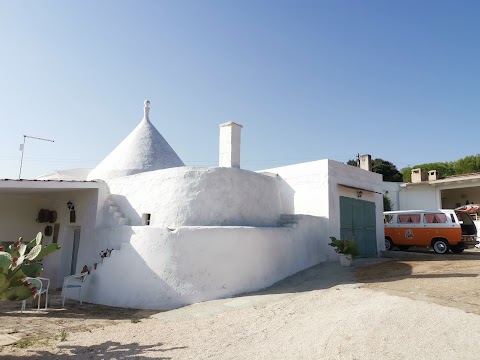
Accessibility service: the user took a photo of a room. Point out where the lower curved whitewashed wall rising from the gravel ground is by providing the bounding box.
[80,216,333,310]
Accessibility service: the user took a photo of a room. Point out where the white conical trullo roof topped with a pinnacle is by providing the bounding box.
[88,100,185,180]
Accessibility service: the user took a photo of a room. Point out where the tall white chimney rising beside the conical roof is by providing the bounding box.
[218,121,243,168]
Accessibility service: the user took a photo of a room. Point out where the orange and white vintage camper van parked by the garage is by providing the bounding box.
[383,210,478,254]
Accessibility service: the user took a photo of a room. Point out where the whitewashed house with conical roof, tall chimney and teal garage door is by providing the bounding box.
[0,102,384,309]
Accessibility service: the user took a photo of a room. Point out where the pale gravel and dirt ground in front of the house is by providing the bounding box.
[0,250,480,359]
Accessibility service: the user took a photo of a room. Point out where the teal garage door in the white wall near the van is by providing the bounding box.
[340,196,377,257]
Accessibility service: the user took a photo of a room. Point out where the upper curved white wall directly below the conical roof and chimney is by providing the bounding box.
[104,167,281,228]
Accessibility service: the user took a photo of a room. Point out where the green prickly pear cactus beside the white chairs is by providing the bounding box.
[0,233,60,301]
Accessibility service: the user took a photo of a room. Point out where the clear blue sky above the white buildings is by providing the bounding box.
[0,0,480,178]
